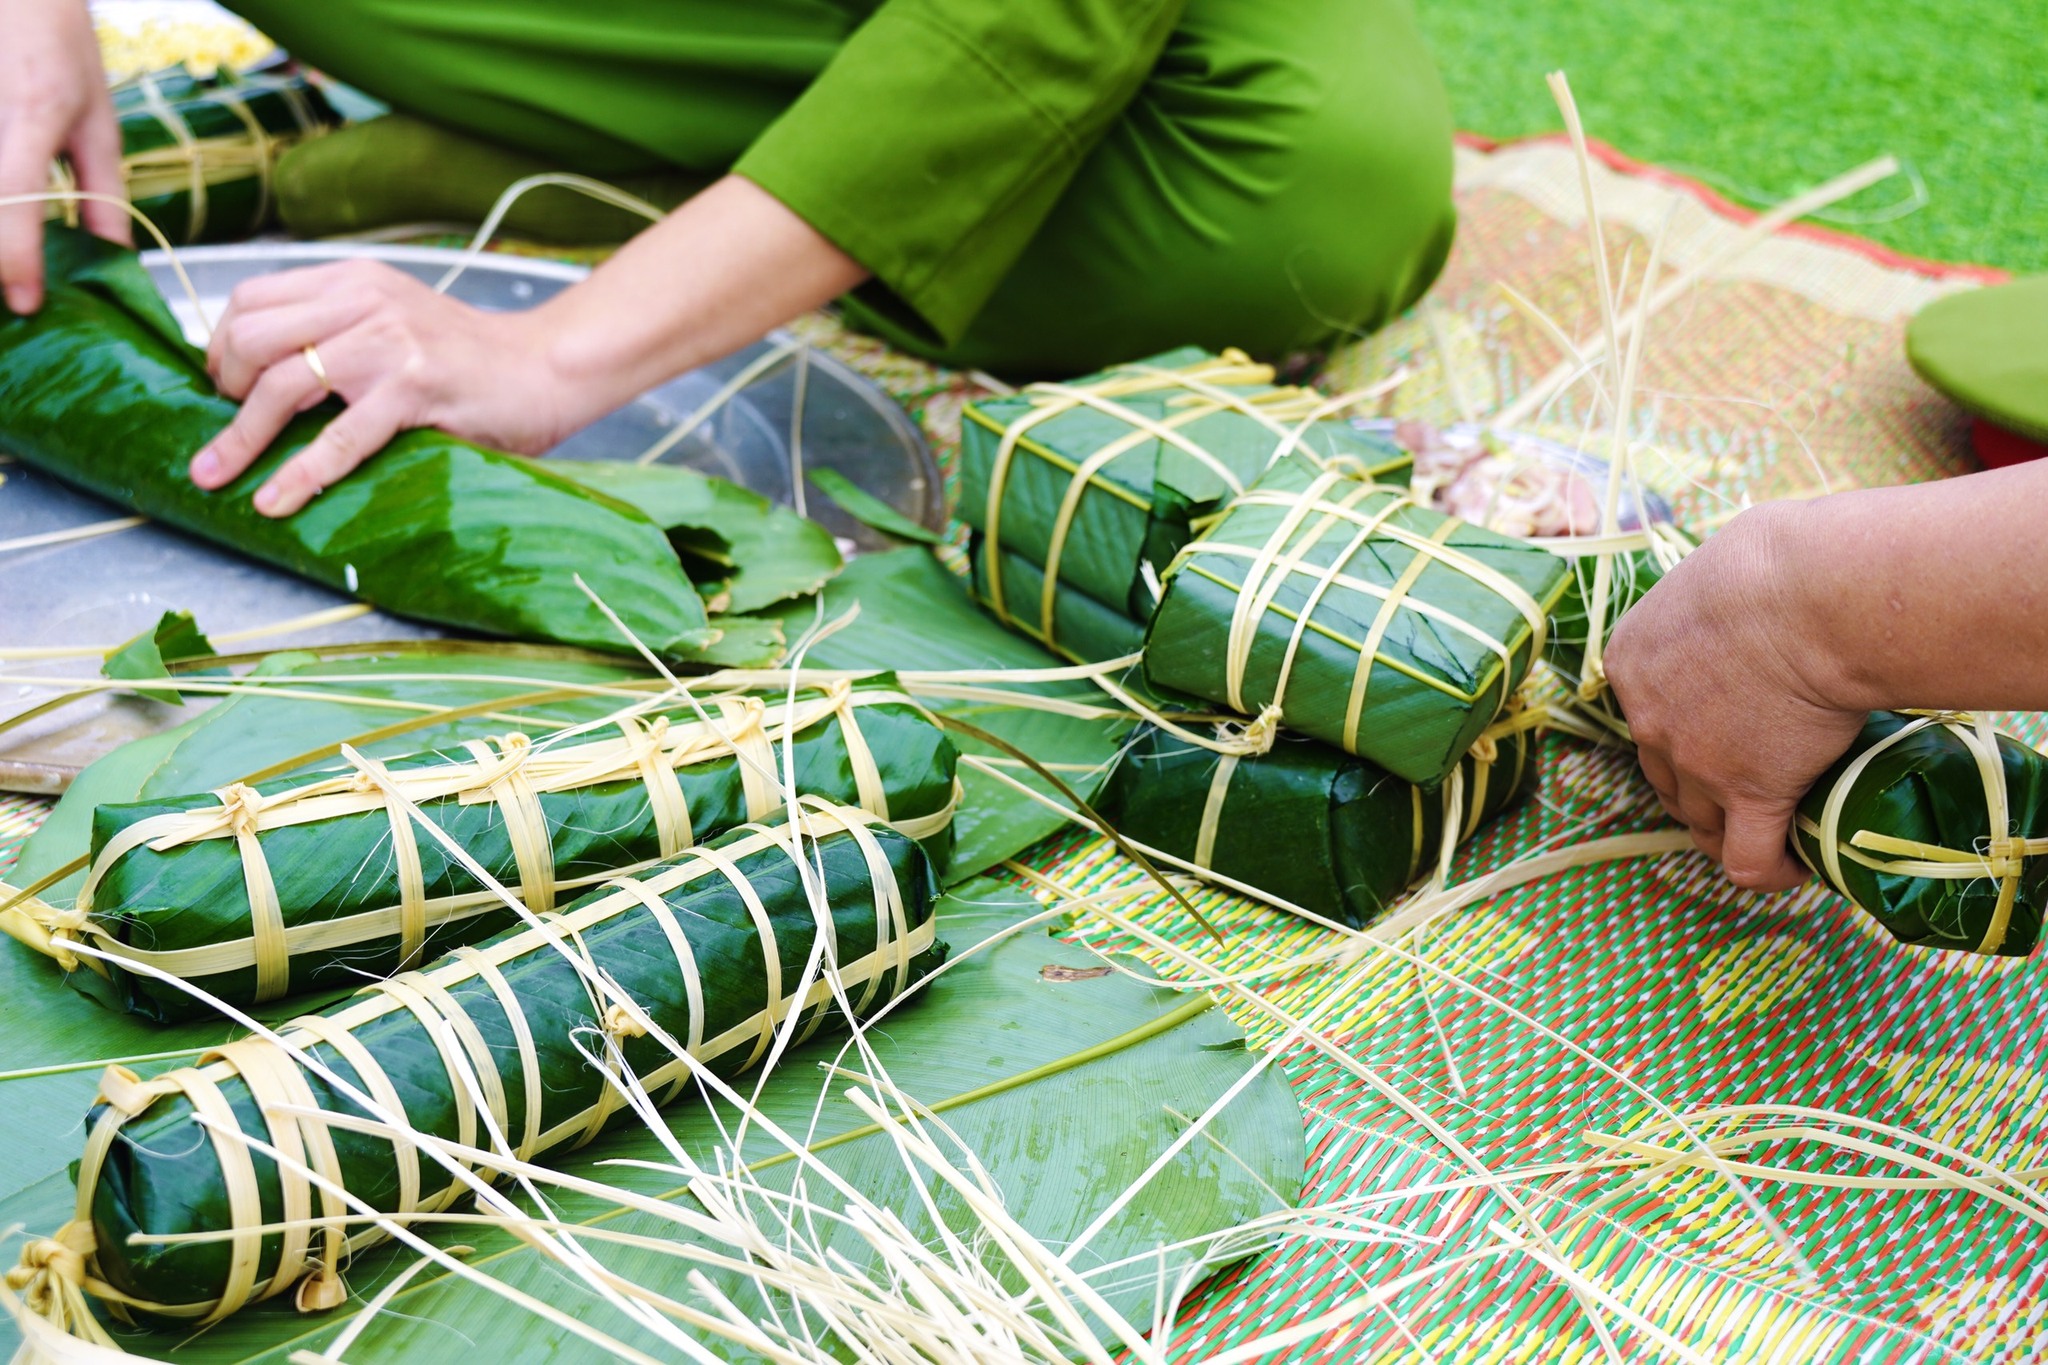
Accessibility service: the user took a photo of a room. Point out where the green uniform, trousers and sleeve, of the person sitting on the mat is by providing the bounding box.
[233,0,1454,377]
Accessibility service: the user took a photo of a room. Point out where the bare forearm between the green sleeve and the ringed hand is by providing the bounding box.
[530,176,866,428]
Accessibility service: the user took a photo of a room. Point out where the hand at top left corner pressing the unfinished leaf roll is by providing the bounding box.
[0,0,131,313]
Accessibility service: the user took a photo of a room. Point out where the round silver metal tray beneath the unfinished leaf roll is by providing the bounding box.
[0,241,944,792]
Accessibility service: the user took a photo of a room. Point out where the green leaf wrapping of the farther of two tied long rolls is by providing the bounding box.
[72,675,954,1019]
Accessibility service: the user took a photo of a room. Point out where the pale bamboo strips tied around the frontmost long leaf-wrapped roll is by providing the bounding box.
[8,798,938,1347]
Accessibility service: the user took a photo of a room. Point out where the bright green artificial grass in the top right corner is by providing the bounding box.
[1415,0,2048,274]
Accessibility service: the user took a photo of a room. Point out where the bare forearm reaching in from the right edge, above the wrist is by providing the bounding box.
[1751,463,2048,710]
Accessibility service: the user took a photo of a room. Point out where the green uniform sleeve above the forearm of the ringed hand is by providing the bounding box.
[733,0,1184,346]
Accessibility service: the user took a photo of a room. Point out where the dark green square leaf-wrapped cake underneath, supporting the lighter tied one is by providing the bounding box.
[1100,720,1536,929]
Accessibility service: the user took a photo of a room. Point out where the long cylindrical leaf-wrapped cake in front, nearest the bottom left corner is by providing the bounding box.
[25,802,946,1326]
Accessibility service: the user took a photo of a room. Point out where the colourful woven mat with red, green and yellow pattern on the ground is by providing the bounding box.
[0,141,2048,1361]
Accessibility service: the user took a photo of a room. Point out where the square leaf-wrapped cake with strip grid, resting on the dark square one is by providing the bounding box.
[1145,456,1571,786]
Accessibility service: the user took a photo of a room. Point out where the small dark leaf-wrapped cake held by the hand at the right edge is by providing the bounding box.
[1794,710,2048,958]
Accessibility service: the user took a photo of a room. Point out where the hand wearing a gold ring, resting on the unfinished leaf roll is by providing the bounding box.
[190,262,581,516]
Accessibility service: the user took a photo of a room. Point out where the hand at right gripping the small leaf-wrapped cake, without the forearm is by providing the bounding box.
[1606,503,1866,890]
